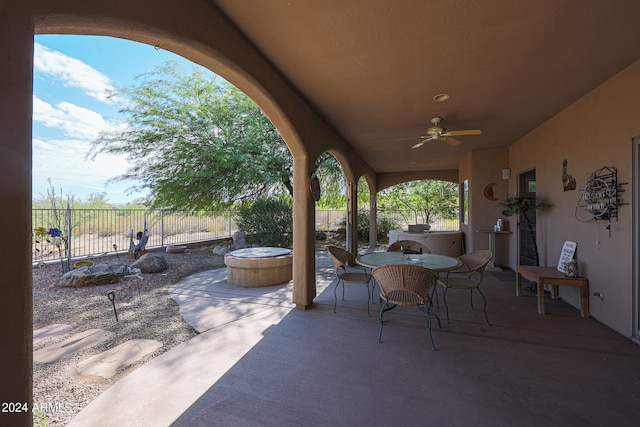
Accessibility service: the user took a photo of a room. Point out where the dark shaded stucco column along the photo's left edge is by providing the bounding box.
[0,6,33,426]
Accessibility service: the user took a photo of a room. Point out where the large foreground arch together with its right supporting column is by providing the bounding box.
[26,0,376,308]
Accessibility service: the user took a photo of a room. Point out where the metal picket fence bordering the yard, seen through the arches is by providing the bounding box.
[32,209,458,262]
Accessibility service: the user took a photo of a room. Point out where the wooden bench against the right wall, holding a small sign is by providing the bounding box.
[516,265,589,317]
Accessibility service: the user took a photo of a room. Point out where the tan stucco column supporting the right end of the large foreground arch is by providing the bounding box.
[293,156,316,309]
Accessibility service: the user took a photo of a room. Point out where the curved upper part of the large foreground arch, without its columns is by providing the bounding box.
[33,0,312,157]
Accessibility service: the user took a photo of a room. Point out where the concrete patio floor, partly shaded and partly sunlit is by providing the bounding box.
[70,252,640,427]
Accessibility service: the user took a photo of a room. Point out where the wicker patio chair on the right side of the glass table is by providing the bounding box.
[438,249,493,325]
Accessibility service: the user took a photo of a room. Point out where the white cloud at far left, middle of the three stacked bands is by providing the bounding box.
[33,95,120,139]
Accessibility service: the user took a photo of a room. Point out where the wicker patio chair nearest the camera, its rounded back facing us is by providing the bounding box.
[371,264,441,350]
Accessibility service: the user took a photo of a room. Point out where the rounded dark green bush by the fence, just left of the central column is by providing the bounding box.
[237,198,293,248]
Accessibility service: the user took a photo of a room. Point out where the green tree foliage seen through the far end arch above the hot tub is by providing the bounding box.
[378,181,458,224]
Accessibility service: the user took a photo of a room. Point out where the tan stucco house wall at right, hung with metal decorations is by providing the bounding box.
[509,61,640,336]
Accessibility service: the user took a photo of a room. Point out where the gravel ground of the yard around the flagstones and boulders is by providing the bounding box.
[33,233,344,426]
